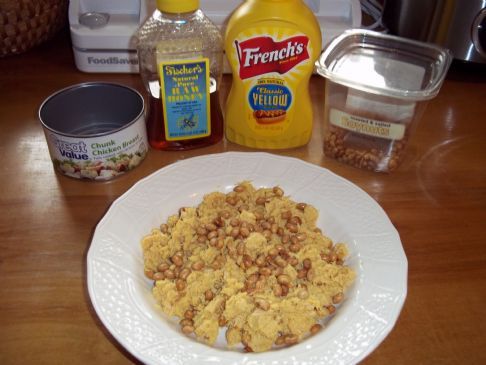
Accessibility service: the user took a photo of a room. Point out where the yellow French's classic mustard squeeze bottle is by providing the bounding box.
[225,0,322,149]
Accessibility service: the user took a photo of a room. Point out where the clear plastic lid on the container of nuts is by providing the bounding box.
[316,29,452,100]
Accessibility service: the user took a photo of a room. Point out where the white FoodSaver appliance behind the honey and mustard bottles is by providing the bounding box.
[69,0,361,72]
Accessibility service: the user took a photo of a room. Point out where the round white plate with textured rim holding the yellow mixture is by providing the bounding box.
[88,153,407,365]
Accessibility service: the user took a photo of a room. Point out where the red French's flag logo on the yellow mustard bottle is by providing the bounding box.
[235,35,309,80]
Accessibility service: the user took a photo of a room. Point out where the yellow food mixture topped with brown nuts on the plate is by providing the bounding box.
[142,182,355,352]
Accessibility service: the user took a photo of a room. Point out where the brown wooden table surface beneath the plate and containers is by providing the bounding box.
[0,32,486,365]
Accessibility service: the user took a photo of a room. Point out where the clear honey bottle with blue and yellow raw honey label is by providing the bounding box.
[136,0,223,150]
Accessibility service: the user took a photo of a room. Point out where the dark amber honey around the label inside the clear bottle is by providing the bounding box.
[147,91,224,151]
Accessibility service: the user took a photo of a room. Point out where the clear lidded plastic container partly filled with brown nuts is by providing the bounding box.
[316,29,452,172]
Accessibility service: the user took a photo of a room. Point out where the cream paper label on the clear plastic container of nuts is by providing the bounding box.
[329,109,405,140]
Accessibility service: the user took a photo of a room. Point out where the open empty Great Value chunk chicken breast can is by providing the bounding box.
[39,82,148,180]
